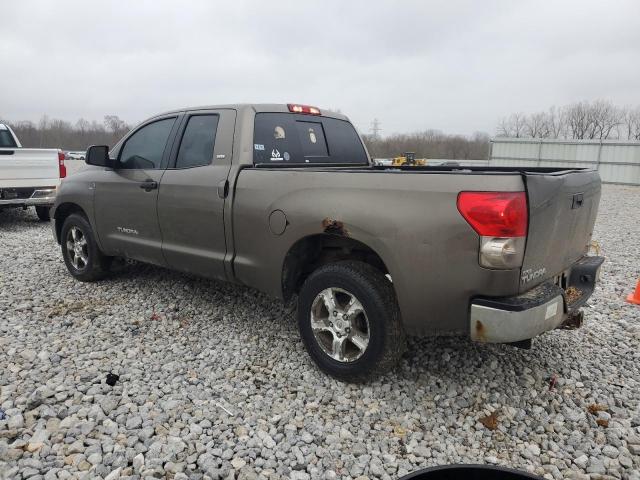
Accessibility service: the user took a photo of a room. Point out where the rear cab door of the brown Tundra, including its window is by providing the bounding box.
[158,109,236,280]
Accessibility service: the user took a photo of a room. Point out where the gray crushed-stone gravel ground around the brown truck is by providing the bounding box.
[0,186,640,480]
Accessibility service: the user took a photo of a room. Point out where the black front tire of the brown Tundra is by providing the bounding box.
[60,213,113,282]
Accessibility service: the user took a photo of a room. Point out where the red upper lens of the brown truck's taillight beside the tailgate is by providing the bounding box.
[458,192,528,237]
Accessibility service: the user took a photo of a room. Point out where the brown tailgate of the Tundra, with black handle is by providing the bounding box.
[520,170,601,292]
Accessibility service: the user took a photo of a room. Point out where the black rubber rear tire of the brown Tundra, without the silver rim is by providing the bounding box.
[297,261,406,382]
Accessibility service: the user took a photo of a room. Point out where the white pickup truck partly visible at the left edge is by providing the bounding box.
[0,123,67,221]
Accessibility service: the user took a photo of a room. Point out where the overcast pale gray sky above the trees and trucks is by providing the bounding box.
[0,0,640,134]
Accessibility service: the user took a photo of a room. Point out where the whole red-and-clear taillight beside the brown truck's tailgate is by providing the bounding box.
[458,192,529,268]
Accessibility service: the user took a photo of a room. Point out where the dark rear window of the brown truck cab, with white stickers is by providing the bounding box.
[253,113,368,165]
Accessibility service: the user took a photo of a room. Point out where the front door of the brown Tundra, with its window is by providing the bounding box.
[94,115,179,265]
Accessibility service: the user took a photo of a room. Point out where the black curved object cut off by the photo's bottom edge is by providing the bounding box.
[401,465,542,480]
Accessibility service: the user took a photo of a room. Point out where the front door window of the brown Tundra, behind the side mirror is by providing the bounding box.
[119,118,176,170]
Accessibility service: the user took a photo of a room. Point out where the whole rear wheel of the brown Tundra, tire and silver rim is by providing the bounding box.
[297,261,406,382]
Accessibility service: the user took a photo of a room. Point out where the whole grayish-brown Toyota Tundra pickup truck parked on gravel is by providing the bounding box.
[52,104,603,381]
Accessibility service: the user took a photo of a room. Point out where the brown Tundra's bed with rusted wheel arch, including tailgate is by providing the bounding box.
[233,165,600,334]
